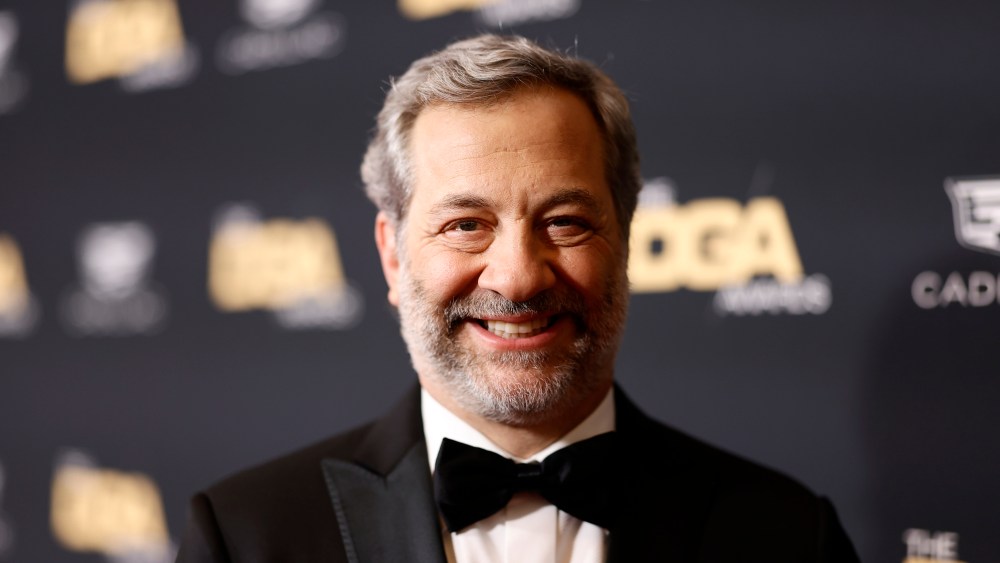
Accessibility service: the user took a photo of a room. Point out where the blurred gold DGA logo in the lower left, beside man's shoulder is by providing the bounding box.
[50,450,175,563]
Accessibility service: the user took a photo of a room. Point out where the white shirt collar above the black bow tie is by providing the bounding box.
[420,387,615,471]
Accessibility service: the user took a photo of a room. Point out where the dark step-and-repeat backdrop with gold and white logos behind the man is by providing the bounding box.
[0,0,1000,563]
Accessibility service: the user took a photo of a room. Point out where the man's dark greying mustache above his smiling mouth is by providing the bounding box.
[444,290,587,330]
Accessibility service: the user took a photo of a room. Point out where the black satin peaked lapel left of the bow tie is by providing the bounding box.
[323,388,445,563]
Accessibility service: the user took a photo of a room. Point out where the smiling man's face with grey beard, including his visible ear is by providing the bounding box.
[377,88,628,425]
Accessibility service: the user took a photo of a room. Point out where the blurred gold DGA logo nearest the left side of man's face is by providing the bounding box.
[208,205,363,329]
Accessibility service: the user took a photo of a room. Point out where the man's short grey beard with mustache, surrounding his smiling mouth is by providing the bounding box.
[399,266,628,426]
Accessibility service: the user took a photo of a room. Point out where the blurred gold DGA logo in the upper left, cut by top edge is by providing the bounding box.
[66,0,198,92]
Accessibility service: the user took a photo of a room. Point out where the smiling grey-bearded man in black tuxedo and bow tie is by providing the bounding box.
[178,35,857,563]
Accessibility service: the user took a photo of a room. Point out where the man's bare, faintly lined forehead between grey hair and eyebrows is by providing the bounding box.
[402,87,610,210]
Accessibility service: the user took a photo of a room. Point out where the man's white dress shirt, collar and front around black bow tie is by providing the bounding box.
[420,389,615,563]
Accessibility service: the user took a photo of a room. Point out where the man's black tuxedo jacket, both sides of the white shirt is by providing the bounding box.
[177,389,858,563]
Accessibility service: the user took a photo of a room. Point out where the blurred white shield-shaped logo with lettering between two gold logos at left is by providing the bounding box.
[62,221,167,336]
